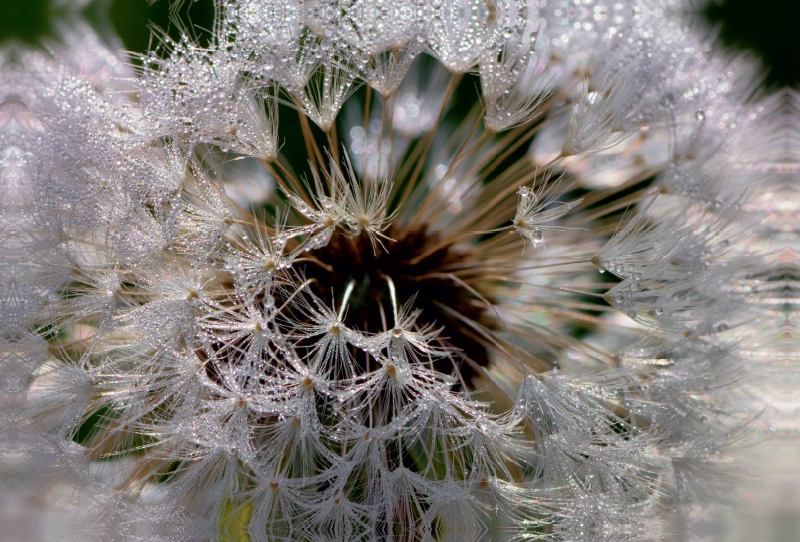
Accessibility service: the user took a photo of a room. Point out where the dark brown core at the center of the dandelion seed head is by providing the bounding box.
[303,228,493,383]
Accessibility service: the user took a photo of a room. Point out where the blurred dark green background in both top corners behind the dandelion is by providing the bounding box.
[0,0,800,87]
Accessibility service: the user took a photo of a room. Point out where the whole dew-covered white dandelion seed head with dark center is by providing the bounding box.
[0,0,780,542]
